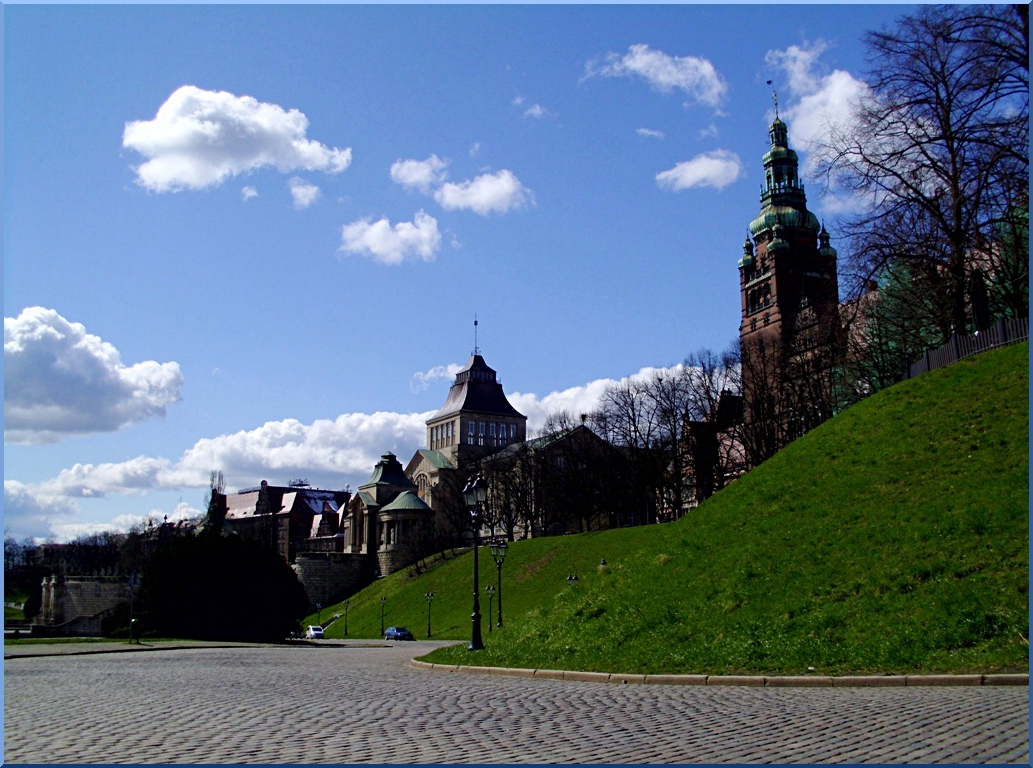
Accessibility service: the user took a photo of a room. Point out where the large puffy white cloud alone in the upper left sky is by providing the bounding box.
[122,86,351,192]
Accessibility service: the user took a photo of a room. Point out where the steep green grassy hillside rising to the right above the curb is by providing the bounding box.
[311,344,1029,674]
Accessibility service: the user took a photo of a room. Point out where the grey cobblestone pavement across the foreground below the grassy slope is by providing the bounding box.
[4,643,1029,764]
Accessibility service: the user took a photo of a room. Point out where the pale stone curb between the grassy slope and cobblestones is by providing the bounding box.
[409,658,1030,688]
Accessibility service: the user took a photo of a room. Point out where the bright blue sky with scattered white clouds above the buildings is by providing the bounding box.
[4,5,908,540]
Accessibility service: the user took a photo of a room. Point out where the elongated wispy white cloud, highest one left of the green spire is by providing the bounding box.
[585,43,728,107]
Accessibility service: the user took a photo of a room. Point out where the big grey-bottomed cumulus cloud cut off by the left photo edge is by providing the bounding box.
[3,307,183,443]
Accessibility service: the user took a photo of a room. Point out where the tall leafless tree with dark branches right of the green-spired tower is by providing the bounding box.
[819,5,1029,341]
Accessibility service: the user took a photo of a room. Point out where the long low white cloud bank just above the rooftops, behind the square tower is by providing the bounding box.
[4,364,706,541]
